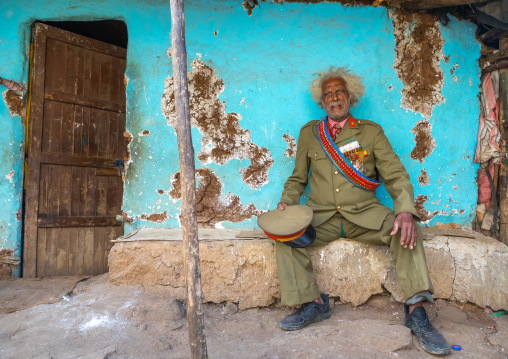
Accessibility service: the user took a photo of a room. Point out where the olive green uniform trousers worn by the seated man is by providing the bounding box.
[276,212,434,306]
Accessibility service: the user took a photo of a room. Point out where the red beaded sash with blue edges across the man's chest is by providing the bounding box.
[316,117,381,191]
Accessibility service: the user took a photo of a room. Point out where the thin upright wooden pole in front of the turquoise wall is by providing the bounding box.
[171,0,208,359]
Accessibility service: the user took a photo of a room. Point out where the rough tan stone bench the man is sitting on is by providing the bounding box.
[109,228,508,310]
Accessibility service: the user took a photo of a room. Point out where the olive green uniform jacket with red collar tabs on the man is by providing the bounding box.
[280,120,419,230]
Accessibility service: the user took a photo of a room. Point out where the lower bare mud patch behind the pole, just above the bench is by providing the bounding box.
[169,168,261,227]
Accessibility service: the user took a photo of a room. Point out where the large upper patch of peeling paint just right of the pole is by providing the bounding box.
[161,59,273,189]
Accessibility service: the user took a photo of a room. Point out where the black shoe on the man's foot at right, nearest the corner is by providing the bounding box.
[404,304,450,354]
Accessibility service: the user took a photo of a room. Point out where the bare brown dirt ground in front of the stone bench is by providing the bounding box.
[0,274,508,359]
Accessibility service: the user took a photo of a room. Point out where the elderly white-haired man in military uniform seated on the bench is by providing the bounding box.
[276,68,449,354]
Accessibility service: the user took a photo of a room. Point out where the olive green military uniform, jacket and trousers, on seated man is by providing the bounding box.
[276,119,433,305]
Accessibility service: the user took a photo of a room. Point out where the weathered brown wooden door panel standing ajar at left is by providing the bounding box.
[23,24,126,277]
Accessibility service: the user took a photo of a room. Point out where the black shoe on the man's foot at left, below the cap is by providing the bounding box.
[279,294,330,330]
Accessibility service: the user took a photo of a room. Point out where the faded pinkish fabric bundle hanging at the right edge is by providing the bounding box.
[474,71,501,208]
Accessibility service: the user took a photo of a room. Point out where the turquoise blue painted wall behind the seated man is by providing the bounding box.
[0,0,480,276]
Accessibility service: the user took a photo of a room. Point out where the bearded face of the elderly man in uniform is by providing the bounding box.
[321,77,351,121]
